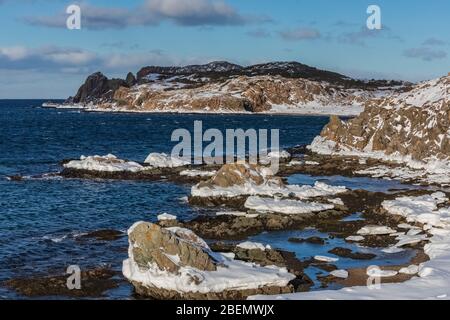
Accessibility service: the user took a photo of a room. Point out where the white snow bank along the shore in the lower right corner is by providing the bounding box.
[250,194,450,300]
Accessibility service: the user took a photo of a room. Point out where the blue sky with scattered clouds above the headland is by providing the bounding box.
[0,0,450,99]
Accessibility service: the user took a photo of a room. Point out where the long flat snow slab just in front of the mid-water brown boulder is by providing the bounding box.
[244,196,334,214]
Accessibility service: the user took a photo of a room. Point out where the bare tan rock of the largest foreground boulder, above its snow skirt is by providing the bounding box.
[129,223,216,273]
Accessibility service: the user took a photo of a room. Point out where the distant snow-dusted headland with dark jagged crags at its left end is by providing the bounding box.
[59,62,404,114]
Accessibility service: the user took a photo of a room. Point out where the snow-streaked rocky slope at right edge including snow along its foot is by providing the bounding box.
[309,76,450,185]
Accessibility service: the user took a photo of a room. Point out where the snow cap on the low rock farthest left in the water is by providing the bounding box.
[64,154,144,173]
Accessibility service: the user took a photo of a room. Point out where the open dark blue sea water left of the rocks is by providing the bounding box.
[0,100,328,298]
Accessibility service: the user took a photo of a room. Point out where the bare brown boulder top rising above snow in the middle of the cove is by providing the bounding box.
[198,163,283,188]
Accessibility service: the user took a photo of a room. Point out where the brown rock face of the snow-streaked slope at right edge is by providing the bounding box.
[321,76,450,160]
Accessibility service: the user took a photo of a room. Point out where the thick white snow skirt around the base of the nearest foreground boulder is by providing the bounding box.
[122,224,295,293]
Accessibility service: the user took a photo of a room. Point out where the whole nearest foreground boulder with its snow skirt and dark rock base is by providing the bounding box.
[122,222,295,300]
